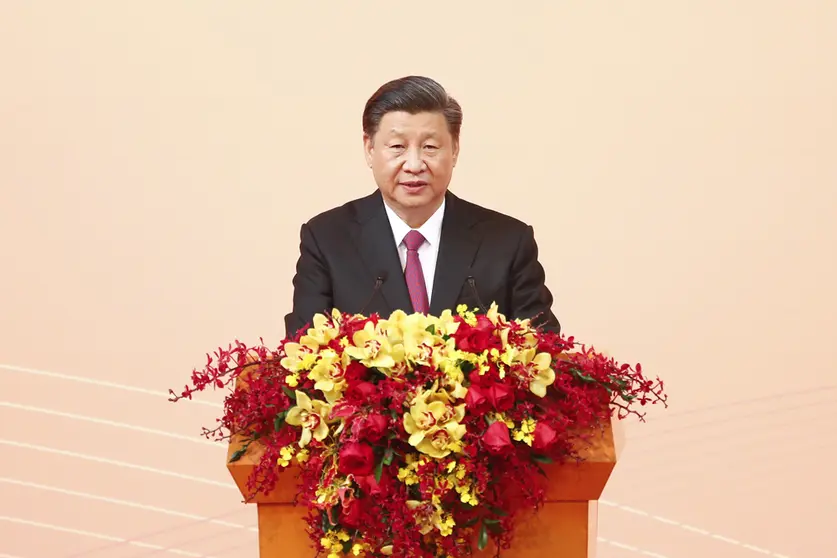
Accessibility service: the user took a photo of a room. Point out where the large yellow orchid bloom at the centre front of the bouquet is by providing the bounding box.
[404,386,466,459]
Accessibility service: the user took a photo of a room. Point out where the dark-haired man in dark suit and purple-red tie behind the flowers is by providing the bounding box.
[285,76,560,337]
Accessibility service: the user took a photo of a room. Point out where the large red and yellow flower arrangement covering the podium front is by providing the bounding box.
[170,304,666,558]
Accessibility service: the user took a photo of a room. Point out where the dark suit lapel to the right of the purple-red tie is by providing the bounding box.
[430,192,480,316]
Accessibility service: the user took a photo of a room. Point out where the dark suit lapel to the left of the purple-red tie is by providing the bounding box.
[353,191,412,315]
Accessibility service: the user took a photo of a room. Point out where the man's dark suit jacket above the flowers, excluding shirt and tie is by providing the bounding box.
[285,190,561,337]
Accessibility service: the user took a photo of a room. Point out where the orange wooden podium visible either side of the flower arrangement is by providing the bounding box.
[227,419,623,558]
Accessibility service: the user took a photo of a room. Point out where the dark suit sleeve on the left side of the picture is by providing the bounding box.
[285,224,334,338]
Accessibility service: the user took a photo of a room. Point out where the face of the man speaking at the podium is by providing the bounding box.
[363,112,459,227]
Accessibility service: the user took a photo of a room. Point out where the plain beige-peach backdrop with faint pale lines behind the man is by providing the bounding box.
[0,0,837,558]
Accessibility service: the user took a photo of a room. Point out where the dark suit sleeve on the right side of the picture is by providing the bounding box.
[511,225,561,333]
